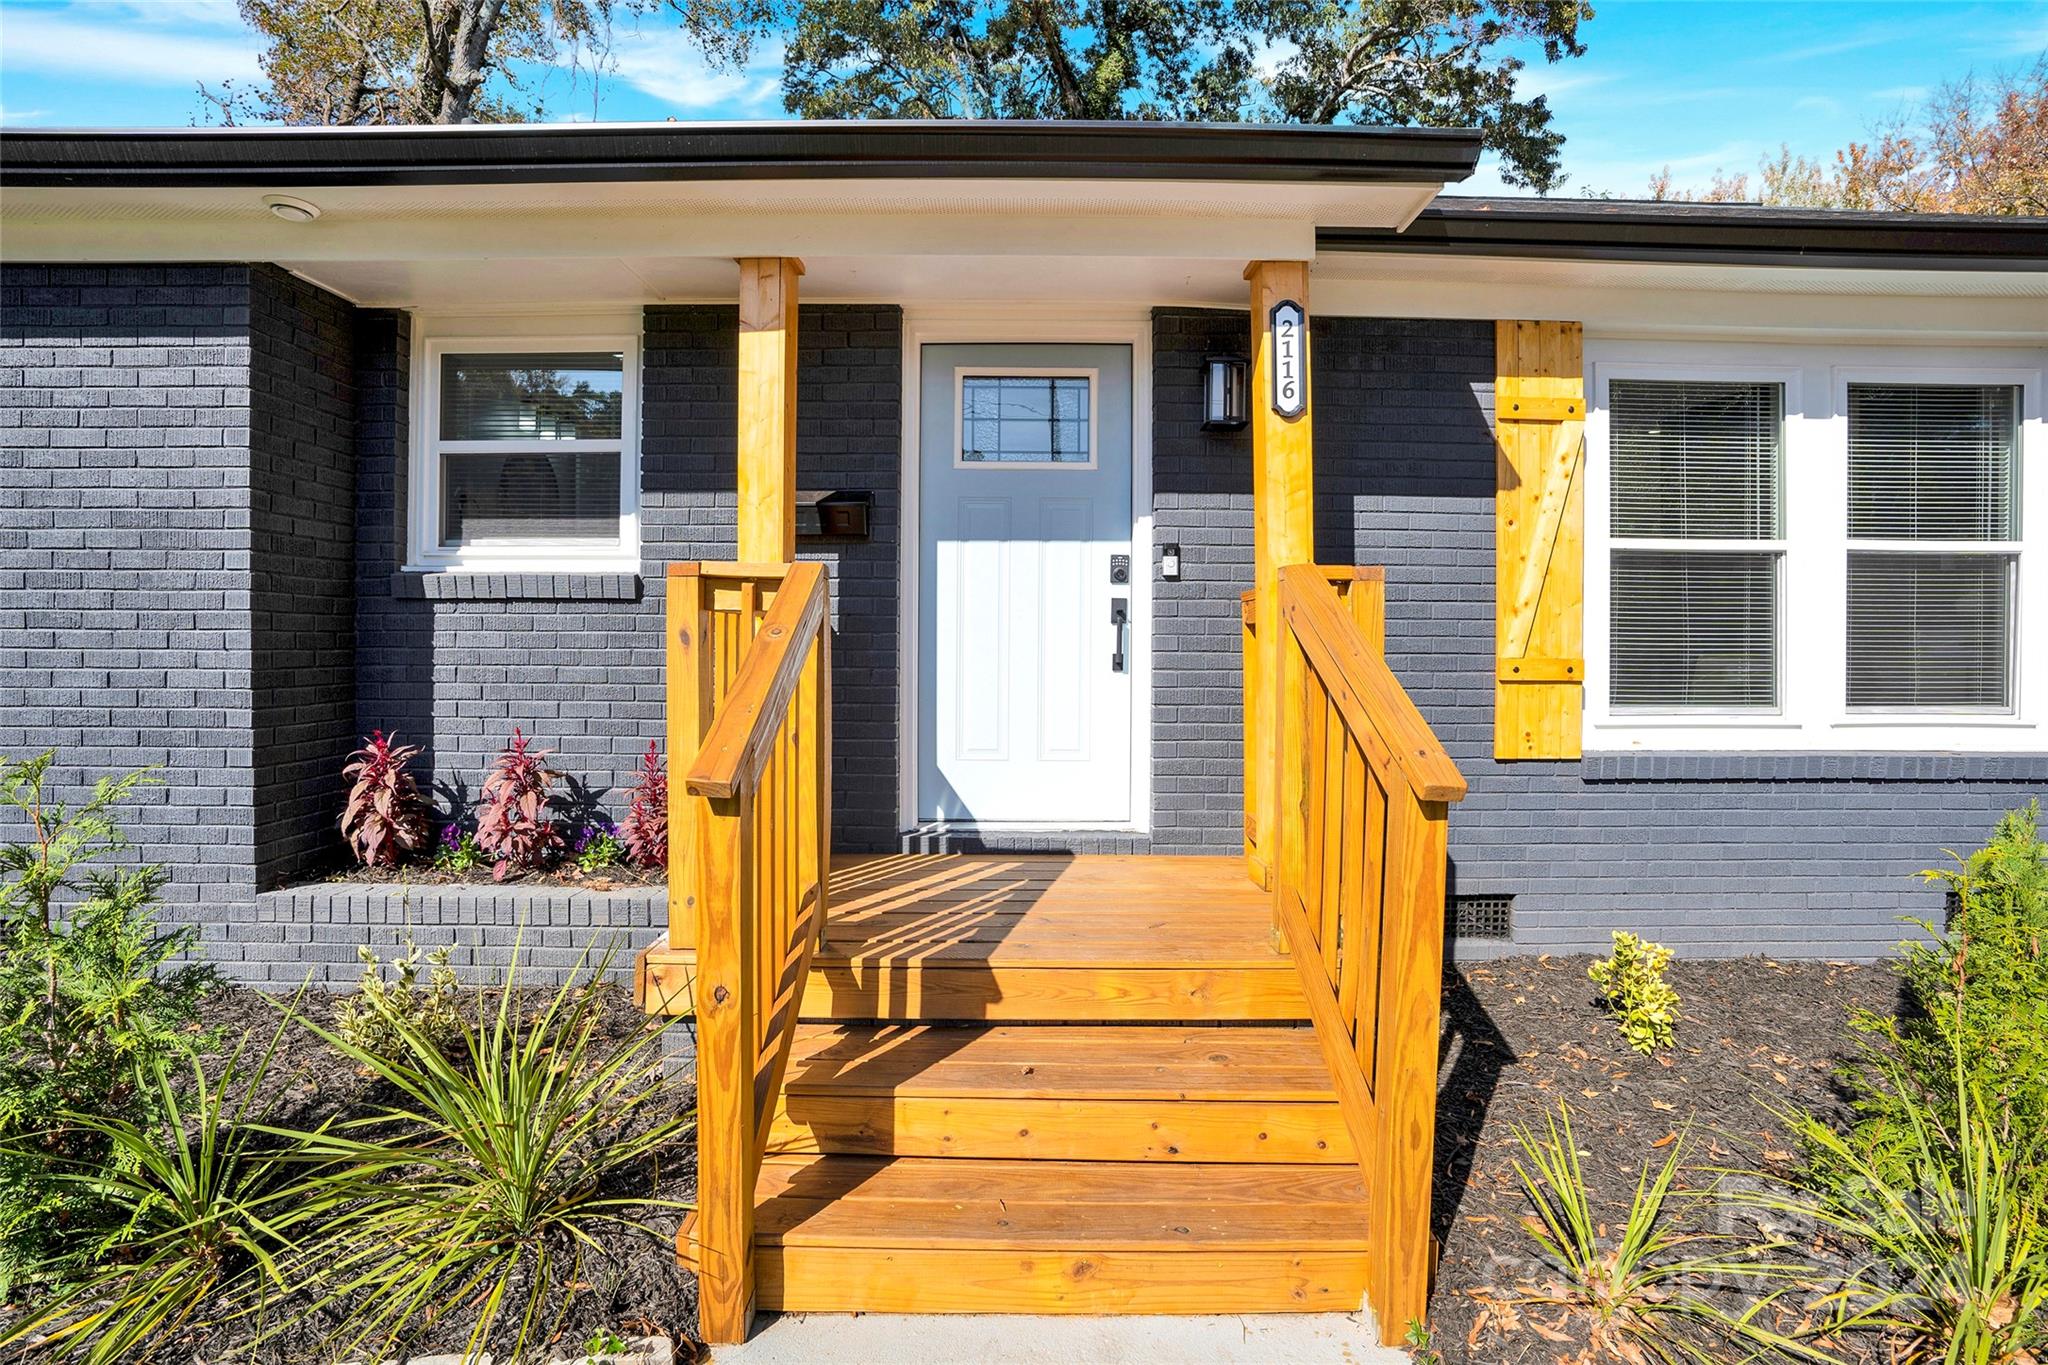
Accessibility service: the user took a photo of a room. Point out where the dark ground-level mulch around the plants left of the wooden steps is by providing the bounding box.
[153,986,696,1365]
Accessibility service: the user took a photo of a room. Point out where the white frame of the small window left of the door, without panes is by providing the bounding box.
[406,315,641,573]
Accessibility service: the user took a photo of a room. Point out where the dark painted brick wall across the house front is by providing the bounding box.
[0,266,2044,980]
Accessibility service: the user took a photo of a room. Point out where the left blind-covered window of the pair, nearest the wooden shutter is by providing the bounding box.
[1608,379,1784,710]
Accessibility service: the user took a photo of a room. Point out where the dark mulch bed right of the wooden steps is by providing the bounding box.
[1432,958,1898,1365]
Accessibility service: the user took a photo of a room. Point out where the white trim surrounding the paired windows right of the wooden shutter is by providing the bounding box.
[1583,338,2048,753]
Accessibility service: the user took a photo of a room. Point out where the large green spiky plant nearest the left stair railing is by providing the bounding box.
[256,945,694,1359]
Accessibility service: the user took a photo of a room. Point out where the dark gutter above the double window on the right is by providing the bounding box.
[1315,199,2048,270]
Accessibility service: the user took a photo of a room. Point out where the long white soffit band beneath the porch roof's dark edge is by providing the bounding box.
[0,180,1440,262]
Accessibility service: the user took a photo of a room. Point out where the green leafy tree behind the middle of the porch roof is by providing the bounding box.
[684,0,1593,190]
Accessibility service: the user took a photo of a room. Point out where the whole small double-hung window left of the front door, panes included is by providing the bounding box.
[412,338,639,571]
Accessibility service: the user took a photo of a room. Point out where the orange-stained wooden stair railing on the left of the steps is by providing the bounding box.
[668,563,831,1342]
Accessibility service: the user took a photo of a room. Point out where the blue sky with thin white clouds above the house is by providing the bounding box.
[0,0,2048,194]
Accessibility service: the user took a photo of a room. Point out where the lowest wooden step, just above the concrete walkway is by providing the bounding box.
[754,1156,1366,1314]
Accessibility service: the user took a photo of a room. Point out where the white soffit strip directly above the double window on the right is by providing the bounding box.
[1313,252,2048,342]
